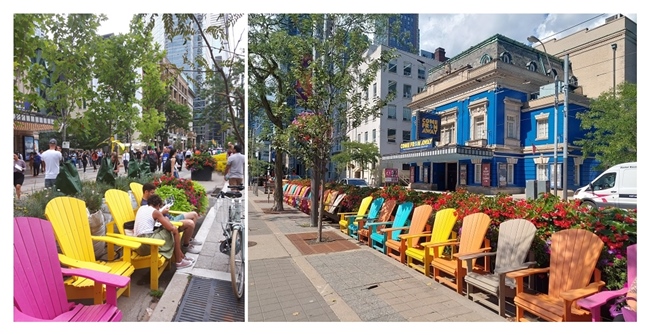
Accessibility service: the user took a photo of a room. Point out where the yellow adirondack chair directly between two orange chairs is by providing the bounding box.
[403,208,458,276]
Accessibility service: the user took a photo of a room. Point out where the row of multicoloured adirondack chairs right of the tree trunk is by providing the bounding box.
[339,196,636,321]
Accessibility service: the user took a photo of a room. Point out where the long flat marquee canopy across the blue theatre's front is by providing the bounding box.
[381,145,494,164]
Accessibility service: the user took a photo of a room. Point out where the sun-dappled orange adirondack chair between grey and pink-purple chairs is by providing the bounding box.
[506,229,605,322]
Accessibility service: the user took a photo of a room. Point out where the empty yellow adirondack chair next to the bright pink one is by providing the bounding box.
[44,197,140,304]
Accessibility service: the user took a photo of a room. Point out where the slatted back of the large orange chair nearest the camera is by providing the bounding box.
[548,229,604,298]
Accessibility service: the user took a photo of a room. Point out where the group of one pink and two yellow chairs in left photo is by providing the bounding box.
[14,184,186,321]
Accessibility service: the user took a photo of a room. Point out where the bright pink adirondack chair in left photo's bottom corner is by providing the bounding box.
[14,217,131,322]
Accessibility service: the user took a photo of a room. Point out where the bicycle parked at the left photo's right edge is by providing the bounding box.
[213,185,246,299]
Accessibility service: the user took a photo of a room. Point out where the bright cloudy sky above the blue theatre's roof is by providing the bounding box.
[420,13,636,58]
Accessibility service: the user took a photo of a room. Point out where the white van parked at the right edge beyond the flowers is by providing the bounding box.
[573,162,637,209]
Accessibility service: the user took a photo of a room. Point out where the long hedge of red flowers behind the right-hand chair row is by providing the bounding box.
[326,184,637,289]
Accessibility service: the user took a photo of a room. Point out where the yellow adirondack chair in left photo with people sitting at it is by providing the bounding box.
[104,189,183,290]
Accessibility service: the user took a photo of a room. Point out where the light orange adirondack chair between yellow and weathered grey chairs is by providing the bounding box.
[427,213,491,294]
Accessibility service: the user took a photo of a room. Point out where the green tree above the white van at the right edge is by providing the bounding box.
[575,82,637,169]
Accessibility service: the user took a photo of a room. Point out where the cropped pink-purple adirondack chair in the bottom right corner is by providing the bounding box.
[578,244,636,322]
